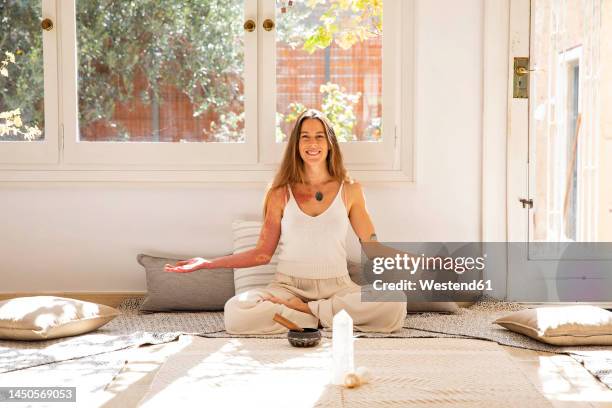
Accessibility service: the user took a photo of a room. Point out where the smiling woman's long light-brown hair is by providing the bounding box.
[263,109,352,220]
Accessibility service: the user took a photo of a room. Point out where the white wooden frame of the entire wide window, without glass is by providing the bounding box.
[0,0,415,183]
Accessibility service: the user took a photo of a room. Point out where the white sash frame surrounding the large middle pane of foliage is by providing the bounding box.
[60,0,257,168]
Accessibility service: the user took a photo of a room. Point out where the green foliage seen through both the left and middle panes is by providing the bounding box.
[0,0,244,138]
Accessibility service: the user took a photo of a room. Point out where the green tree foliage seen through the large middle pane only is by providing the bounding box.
[77,0,244,140]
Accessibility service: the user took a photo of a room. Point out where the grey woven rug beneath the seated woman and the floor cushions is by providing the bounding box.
[0,297,612,389]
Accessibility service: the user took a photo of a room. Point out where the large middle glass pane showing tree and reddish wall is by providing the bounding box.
[76,0,244,142]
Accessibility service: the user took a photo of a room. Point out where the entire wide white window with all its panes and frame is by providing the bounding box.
[0,0,412,178]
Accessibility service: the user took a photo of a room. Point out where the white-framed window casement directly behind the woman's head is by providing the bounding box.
[262,0,405,166]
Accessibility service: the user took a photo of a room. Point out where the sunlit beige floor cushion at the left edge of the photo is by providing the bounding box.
[0,296,120,340]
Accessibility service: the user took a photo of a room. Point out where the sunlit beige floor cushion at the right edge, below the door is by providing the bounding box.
[495,305,612,346]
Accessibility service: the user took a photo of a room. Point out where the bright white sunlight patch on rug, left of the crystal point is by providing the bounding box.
[142,339,331,407]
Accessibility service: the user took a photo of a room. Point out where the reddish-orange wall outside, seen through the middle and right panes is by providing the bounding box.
[81,38,382,142]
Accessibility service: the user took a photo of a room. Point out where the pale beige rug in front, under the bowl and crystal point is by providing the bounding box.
[138,338,552,408]
